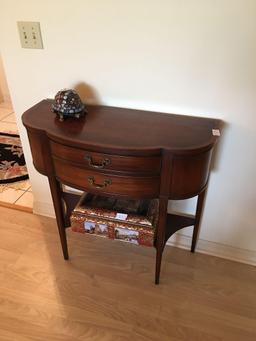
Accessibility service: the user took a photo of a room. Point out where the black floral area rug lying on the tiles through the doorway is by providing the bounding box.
[0,133,28,184]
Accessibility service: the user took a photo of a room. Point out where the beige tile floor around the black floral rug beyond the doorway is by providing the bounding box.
[0,103,33,212]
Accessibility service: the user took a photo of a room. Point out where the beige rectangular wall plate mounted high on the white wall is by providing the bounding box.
[17,21,43,49]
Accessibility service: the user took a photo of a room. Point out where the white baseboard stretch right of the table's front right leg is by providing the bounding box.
[167,233,256,265]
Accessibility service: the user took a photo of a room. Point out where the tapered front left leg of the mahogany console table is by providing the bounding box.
[48,178,68,259]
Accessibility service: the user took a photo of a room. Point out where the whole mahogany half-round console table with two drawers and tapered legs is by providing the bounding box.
[22,100,220,284]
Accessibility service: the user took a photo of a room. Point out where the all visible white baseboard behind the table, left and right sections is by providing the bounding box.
[33,201,256,265]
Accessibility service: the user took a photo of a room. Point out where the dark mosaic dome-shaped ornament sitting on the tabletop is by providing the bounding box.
[52,89,85,120]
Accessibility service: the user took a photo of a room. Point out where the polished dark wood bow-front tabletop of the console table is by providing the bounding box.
[22,100,220,156]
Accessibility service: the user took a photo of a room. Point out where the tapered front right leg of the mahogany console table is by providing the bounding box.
[155,198,168,284]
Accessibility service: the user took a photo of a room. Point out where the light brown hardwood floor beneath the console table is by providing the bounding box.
[0,207,256,341]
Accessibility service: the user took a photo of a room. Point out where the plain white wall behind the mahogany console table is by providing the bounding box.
[0,0,256,260]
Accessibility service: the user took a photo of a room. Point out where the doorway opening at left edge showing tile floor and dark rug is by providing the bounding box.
[0,55,33,212]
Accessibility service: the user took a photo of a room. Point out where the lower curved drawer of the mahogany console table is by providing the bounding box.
[53,158,160,198]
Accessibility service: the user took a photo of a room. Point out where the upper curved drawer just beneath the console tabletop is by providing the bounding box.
[50,141,161,174]
